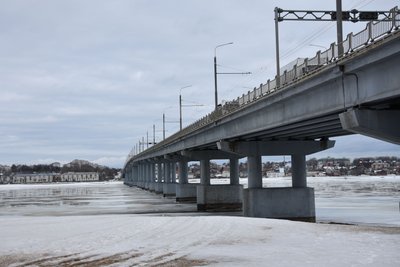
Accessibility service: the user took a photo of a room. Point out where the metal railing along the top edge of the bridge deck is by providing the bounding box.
[127,7,400,165]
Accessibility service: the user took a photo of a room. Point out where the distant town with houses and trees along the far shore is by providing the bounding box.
[0,156,400,184]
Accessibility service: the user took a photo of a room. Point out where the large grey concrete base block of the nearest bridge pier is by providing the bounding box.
[243,187,315,222]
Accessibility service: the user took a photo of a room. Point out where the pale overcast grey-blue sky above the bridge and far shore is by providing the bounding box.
[0,0,400,167]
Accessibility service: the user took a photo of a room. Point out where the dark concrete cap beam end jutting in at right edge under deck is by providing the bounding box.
[339,109,400,145]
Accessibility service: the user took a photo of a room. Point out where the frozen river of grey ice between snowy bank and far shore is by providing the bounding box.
[0,176,400,226]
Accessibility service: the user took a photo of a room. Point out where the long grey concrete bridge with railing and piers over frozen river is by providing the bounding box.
[123,13,400,221]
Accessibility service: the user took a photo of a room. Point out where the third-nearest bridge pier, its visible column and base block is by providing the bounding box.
[176,160,197,203]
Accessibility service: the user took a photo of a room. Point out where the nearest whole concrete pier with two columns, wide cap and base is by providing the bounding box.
[219,140,335,221]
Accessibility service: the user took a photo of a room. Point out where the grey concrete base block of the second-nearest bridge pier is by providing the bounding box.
[197,185,243,211]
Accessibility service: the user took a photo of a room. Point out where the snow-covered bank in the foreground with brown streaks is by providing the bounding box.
[0,215,400,266]
